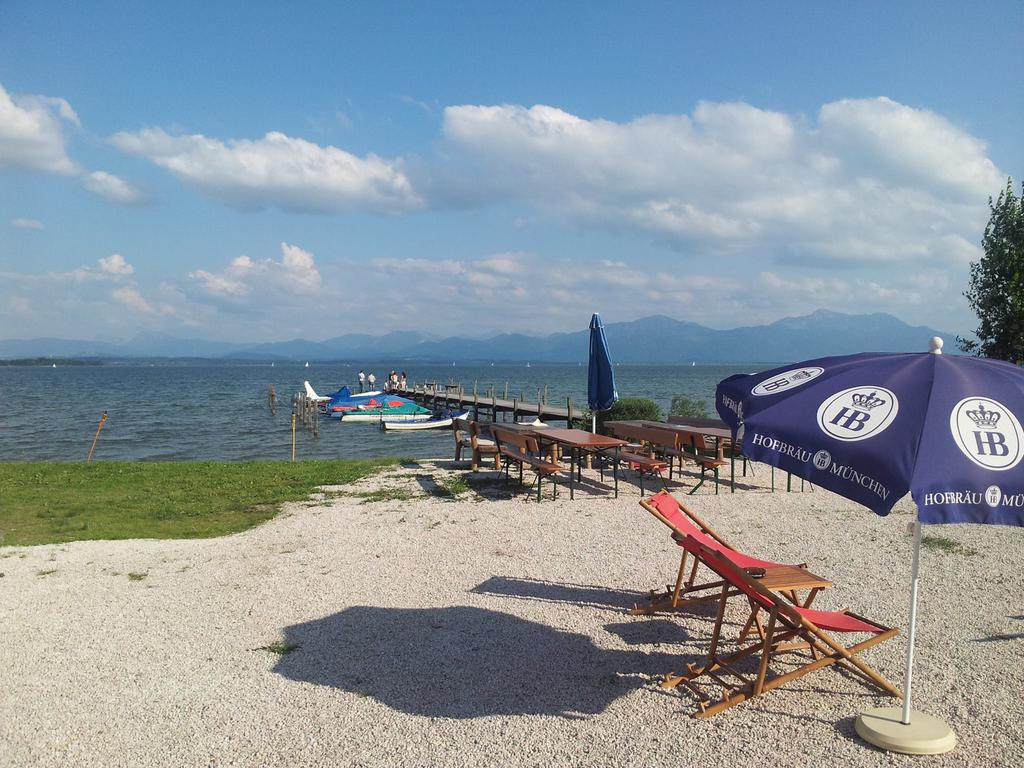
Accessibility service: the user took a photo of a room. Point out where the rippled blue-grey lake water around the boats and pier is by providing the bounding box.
[0,362,771,461]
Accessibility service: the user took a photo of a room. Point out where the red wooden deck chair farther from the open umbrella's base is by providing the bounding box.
[631,490,831,618]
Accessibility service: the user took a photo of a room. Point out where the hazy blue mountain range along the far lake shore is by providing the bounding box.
[0,309,955,364]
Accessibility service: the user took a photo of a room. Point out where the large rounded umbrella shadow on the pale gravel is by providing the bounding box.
[273,606,681,719]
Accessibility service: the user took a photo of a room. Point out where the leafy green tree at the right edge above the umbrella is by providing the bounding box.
[956,179,1024,362]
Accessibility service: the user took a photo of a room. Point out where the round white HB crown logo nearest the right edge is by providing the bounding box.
[949,397,1022,471]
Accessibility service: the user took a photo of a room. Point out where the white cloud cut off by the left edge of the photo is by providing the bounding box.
[0,85,79,175]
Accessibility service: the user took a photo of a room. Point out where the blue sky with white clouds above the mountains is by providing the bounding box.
[0,0,1024,341]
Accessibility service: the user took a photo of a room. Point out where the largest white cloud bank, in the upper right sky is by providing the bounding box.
[434,98,1005,264]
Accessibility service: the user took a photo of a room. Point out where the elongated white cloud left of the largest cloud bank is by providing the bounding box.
[111,128,422,213]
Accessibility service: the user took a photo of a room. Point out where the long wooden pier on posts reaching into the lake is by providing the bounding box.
[390,382,584,426]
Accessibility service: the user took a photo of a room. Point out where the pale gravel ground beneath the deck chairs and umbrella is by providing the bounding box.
[0,461,1024,766]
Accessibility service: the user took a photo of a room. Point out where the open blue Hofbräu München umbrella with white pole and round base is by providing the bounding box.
[715,338,1024,753]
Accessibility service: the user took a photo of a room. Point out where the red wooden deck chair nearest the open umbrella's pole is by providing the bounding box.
[662,537,902,718]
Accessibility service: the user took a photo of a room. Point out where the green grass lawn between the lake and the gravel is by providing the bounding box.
[0,459,395,546]
